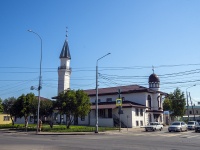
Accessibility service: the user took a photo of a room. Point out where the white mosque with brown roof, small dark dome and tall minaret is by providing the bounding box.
[58,33,167,128]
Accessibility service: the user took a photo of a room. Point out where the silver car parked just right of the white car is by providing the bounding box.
[168,121,188,132]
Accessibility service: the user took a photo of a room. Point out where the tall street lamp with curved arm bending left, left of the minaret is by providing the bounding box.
[28,30,42,134]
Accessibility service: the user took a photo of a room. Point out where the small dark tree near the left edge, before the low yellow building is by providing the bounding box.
[3,97,16,125]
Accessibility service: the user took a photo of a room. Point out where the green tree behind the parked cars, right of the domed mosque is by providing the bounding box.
[168,88,186,117]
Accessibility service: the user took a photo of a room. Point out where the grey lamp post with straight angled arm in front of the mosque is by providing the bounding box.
[95,53,110,133]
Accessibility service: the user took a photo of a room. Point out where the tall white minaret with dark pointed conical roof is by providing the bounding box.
[58,29,71,94]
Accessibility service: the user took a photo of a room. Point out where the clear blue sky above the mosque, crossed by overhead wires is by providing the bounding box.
[0,0,200,103]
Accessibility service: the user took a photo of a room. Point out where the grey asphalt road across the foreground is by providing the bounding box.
[0,129,200,150]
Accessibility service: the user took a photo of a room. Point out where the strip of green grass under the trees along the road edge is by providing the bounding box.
[0,124,118,132]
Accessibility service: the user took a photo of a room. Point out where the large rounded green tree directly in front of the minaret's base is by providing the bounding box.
[56,90,91,128]
